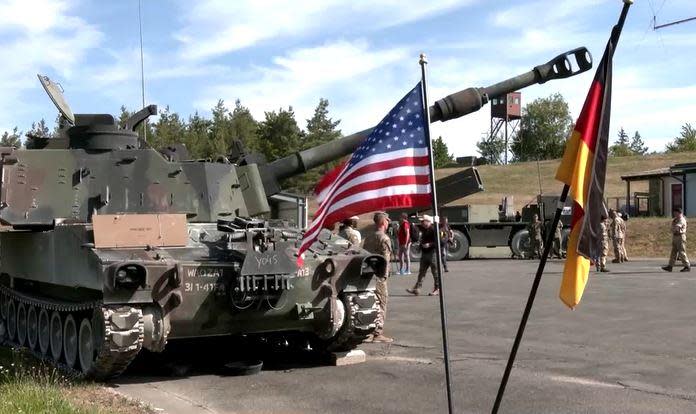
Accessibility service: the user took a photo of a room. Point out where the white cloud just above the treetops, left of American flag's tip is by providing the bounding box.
[196,40,407,132]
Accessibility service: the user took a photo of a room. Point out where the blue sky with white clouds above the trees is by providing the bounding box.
[0,0,696,156]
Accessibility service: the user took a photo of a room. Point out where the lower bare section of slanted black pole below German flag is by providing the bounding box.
[492,185,570,414]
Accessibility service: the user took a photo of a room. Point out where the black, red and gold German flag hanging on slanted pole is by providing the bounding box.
[556,19,623,309]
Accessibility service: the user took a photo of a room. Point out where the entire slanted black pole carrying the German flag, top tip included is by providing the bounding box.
[491,0,633,414]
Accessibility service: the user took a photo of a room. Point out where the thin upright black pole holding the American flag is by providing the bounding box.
[418,53,454,414]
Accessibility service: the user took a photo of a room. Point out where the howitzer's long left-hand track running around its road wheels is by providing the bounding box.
[0,285,144,381]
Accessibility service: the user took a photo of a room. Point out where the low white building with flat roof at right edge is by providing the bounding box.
[624,163,696,217]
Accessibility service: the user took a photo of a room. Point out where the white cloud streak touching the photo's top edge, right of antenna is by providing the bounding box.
[175,0,474,59]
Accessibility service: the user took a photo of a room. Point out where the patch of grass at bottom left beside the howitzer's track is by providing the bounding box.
[0,346,152,414]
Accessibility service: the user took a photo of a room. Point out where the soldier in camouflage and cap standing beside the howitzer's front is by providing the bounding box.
[363,212,394,342]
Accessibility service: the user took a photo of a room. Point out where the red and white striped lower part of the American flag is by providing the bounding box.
[298,147,430,263]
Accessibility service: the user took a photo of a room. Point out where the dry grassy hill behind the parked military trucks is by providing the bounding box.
[436,152,696,209]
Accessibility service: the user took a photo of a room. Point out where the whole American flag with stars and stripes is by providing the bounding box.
[298,82,431,265]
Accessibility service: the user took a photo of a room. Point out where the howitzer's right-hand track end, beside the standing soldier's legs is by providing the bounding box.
[326,291,379,352]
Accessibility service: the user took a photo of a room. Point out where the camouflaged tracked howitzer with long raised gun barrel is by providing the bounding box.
[0,49,591,379]
